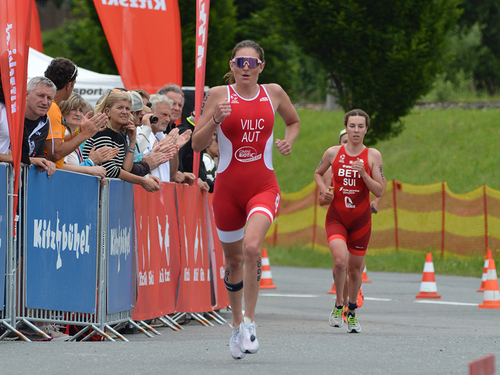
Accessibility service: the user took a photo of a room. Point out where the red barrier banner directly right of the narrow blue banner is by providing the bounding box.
[132,183,180,320]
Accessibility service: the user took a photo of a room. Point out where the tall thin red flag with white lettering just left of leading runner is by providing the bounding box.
[193,0,210,178]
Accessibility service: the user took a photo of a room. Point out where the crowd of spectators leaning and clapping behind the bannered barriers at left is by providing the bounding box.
[0,57,218,339]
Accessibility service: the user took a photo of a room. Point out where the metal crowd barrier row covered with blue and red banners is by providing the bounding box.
[0,164,229,341]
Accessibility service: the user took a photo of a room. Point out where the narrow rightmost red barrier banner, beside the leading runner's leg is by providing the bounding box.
[207,194,229,310]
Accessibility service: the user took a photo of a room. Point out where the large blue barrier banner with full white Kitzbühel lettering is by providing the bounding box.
[26,167,99,313]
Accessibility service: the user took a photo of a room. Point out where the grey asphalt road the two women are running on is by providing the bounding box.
[0,266,500,375]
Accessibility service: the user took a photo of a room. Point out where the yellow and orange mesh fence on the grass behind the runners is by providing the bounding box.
[265,180,500,256]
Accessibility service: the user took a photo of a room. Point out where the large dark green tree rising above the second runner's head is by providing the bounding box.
[271,0,460,144]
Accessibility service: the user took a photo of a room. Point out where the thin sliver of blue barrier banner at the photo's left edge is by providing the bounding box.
[0,164,7,311]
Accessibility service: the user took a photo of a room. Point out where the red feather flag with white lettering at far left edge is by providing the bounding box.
[0,0,32,216]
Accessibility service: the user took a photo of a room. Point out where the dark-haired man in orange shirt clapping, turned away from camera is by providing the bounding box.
[44,57,107,169]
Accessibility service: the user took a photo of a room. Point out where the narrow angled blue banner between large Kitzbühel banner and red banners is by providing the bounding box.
[107,180,134,314]
